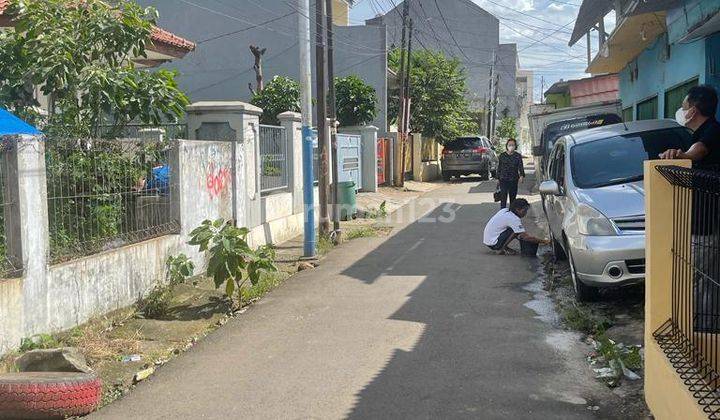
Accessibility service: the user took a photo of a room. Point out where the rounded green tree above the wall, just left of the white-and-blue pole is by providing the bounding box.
[250,76,300,125]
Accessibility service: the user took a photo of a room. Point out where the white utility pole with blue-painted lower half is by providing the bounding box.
[298,0,316,258]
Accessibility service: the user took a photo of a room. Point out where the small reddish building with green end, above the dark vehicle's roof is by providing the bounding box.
[543,74,619,108]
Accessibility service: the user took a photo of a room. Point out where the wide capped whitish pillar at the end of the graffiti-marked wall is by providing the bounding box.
[187,101,262,228]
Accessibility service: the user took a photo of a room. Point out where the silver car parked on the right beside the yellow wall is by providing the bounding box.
[540,120,691,301]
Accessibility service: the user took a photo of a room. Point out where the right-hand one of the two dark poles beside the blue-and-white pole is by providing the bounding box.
[325,0,341,243]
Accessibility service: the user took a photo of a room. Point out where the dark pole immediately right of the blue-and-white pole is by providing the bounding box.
[315,0,330,235]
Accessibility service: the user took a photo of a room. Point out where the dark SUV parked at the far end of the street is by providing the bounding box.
[440,137,498,181]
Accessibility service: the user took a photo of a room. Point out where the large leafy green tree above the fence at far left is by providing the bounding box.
[0,0,188,137]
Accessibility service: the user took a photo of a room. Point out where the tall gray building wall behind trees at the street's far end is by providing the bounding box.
[367,0,517,116]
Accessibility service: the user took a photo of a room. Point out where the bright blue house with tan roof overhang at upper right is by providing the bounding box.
[570,0,720,120]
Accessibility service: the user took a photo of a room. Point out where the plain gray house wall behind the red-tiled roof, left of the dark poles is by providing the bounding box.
[138,0,387,132]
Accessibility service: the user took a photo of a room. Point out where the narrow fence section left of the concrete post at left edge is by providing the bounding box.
[0,137,22,278]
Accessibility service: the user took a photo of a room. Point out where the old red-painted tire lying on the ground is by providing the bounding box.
[0,372,102,419]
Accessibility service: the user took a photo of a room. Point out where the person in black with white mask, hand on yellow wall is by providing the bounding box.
[660,85,720,170]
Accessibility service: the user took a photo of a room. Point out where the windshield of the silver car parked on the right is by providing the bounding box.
[570,127,692,188]
